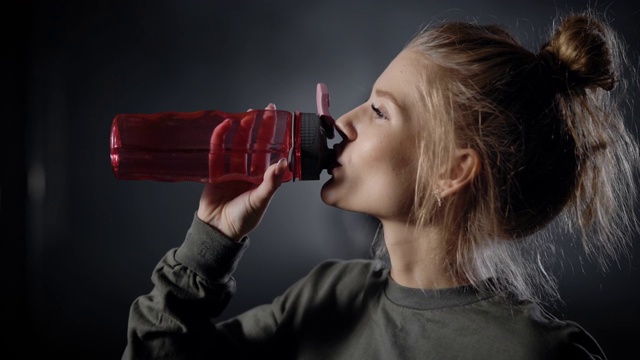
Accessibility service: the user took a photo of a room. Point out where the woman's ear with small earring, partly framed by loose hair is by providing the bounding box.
[436,149,481,198]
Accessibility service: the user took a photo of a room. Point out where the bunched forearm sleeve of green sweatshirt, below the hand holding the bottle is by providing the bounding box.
[122,215,249,359]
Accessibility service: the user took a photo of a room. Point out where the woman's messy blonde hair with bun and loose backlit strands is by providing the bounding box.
[378,13,639,300]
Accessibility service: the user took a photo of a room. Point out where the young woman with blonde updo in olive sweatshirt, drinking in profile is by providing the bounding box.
[124,14,639,359]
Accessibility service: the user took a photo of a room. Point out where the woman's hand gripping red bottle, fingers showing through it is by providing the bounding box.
[197,104,288,241]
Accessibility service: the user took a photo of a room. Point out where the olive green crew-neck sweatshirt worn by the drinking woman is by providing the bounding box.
[123,217,605,360]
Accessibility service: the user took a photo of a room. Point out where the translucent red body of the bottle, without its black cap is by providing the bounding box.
[110,110,293,184]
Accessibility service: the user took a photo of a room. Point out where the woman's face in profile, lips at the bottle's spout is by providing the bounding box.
[321,50,424,221]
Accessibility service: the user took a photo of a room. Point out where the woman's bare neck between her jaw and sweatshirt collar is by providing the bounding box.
[382,221,461,289]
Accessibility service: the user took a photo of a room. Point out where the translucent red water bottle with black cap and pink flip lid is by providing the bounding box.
[110,83,335,184]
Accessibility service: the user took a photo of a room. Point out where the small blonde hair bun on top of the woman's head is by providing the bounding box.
[538,15,616,91]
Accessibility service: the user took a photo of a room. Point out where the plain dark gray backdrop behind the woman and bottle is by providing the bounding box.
[0,0,640,359]
